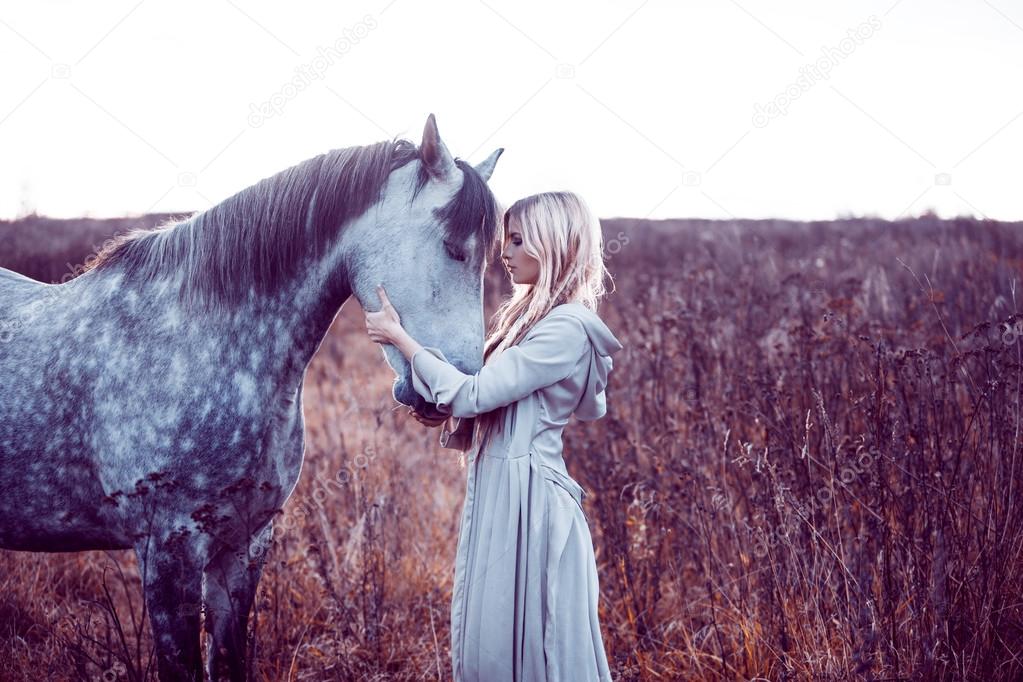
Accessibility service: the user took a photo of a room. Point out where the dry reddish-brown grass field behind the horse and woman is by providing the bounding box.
[0,211,1023,682]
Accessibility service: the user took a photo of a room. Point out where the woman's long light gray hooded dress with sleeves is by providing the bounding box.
[411,303,622,682]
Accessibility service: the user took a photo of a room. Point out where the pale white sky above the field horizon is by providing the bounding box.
[0,0,1023,220]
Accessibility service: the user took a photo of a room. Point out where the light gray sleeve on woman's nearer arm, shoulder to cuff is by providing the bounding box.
[410,315,589,417]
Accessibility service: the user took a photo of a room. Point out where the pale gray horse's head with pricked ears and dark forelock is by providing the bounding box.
[343,115,503,415]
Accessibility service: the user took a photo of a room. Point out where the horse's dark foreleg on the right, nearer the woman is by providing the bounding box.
[203,524,271,682]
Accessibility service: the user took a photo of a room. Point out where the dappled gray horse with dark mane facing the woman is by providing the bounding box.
[0,116,501,680]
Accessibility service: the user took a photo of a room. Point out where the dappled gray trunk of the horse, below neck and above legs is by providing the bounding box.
[0,270,311,551]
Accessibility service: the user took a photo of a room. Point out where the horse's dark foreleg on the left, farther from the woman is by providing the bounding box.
[135,537,203,682]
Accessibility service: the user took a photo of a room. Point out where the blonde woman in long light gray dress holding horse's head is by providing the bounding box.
[366,192,622,682]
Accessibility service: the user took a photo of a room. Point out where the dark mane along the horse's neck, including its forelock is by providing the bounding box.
[85,139,500,314]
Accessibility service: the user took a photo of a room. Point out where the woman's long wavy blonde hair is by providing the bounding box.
[472,191,614,439]
